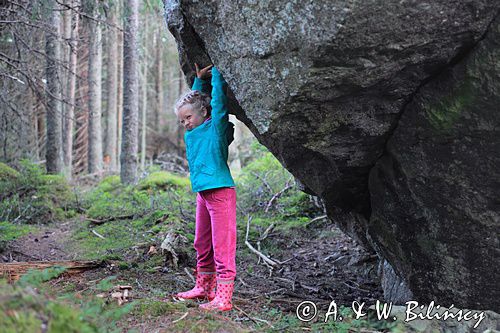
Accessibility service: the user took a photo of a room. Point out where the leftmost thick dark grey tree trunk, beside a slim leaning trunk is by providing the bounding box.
[45,0,63,173]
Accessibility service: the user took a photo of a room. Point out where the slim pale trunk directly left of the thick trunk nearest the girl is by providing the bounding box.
[104,4,118,171]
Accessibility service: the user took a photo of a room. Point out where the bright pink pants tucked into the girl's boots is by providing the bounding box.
[194,187,236,280]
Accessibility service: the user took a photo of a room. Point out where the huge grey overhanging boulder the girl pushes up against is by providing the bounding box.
[165,0,500,309]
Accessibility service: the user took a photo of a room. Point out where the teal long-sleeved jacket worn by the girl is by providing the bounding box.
[184,67,235,192]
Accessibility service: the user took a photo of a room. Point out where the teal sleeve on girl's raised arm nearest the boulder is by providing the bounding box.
[210,67,229,135]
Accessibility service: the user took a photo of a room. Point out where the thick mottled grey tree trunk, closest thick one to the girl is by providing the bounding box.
[120,0,139,184]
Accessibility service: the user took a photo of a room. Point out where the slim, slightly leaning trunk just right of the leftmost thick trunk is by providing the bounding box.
[63,0,80,178]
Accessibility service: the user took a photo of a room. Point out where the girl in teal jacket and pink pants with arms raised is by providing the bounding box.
[175,64,236,311]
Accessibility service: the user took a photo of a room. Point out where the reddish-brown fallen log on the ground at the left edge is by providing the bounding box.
[0,260,102,282]
